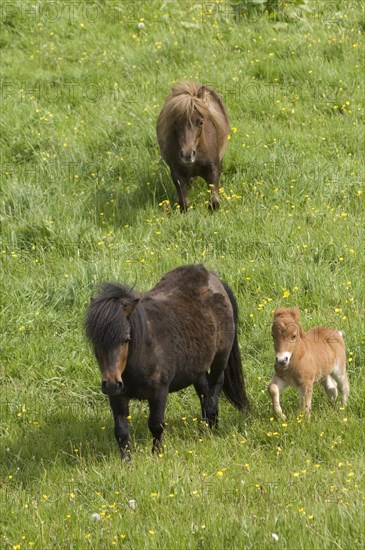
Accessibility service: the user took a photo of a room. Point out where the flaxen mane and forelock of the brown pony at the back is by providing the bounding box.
[158,82,228,146]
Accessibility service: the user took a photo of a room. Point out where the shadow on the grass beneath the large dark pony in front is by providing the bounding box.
[0,392,250,486]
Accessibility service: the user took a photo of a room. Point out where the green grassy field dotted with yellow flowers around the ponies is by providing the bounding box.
[0,0,365,550]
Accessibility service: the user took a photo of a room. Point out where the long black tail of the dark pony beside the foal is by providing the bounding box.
[222,281,249,411]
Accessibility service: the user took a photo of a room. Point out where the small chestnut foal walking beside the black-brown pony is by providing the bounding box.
[268,307,349,419]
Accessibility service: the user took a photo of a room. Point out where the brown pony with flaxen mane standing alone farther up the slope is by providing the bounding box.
[157,82,228,212]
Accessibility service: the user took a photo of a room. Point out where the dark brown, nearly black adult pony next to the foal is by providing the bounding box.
[86,265,248,460]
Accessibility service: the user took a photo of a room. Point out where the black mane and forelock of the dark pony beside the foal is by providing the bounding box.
[85,283,144,349]
